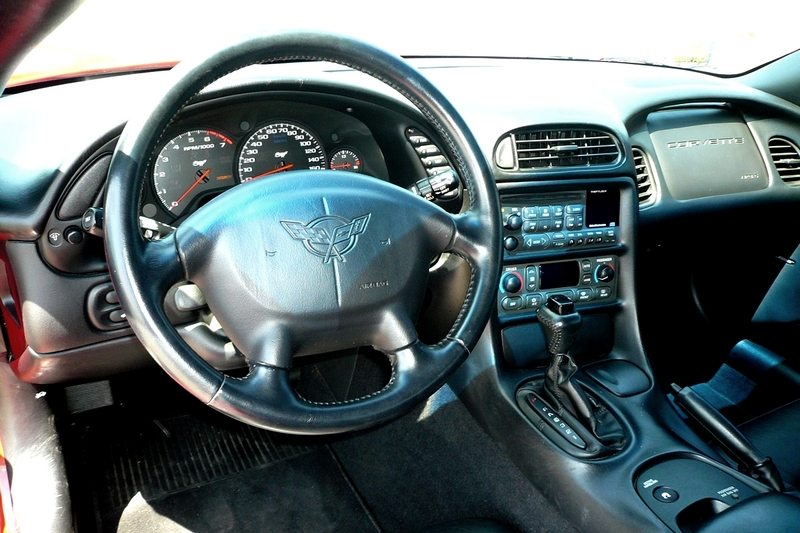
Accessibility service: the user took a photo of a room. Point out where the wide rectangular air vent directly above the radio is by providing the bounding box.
[514,129,620,170]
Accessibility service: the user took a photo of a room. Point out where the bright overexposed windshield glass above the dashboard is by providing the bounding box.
[10,0,800,85]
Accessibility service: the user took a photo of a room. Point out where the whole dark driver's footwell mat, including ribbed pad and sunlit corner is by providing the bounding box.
[66,409,375,532]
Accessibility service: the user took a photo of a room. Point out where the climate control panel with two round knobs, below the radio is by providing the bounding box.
[497,255,618,316]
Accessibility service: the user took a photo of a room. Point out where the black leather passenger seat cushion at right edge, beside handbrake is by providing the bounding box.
[740,400,800,487]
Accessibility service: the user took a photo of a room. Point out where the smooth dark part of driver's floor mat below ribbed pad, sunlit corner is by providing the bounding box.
[119,448,377,533]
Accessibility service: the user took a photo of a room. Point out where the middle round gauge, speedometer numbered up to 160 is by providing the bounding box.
[239,122,328,182]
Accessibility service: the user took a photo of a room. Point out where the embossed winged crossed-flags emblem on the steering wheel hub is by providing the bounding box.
[281,213,372,263]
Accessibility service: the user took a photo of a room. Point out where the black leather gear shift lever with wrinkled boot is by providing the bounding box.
[536,294,597,435]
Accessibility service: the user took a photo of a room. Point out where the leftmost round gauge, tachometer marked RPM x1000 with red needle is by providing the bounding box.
[153,130,236,216]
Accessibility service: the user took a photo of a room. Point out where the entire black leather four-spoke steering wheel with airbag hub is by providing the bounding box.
[105,33,500,434]
